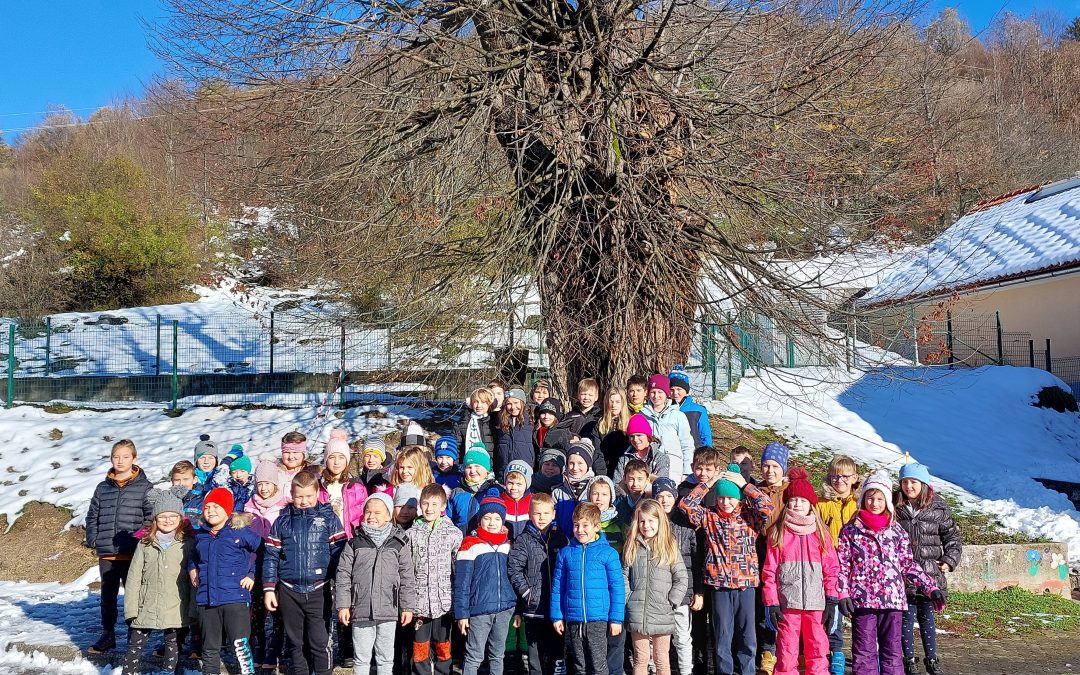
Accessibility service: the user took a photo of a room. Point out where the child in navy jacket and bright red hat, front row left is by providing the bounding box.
[188,487,261,674]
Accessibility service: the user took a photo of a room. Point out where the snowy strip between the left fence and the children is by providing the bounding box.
[0,396,460,525]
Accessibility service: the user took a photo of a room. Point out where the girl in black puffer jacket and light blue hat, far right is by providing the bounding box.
[895,461,962,675]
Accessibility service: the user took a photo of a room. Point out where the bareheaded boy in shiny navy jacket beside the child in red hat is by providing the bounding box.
[262,471,346,675]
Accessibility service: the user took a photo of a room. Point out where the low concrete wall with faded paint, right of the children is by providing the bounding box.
[946,543,1071,597]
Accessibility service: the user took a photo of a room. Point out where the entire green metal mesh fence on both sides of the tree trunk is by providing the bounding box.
[0,310,1080,408]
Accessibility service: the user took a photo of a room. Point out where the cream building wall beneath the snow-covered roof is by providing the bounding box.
[916,273,1080,365]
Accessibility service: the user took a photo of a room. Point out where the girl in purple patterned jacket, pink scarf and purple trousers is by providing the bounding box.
[837,469,945,675]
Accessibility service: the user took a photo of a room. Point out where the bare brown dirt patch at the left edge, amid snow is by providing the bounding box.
[0,501,97,583]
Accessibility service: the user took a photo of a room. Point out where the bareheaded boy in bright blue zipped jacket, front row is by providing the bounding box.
[551,502,626,675]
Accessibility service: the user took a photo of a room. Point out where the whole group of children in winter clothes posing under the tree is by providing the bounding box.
[86,374,960,675]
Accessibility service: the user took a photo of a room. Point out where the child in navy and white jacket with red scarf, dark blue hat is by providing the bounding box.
[454,496,517,675]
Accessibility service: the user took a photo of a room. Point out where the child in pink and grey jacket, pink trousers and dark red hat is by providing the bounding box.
[761,469,840,675]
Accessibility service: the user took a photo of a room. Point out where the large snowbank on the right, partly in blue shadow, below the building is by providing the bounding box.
[712,366,1080,562]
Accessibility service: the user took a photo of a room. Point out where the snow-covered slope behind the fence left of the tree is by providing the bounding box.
[0,279,545,384]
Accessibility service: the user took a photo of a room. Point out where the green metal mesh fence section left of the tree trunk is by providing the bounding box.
[0,313,546,408]
